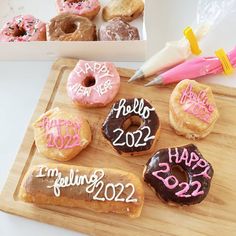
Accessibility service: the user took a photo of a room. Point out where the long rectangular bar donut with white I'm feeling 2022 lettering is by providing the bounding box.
[18,163,144,218]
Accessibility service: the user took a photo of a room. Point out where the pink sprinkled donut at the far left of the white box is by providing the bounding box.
[0,15,46,42]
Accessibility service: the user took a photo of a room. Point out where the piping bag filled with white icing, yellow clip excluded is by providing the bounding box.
[129,0,236,82]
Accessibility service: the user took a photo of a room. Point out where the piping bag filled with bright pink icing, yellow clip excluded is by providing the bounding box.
[145,48,236,86]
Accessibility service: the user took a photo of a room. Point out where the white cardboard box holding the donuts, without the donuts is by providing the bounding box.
[0,0,147,61]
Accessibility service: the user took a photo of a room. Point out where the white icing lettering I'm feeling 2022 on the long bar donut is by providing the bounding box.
[35,166,138,203]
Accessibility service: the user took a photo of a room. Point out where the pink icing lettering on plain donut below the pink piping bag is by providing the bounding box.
[180,83,214,123]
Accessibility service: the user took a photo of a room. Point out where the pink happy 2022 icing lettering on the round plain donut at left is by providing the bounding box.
[38,116,82,150]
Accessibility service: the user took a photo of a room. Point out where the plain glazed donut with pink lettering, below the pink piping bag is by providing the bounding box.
[169,80,219,139]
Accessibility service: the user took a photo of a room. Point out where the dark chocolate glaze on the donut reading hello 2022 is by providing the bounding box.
[102,98,160,155]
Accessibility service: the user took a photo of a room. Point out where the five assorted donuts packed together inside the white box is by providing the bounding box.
[0,0,144,42]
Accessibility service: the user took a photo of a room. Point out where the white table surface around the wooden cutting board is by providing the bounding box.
[0,0,236,236]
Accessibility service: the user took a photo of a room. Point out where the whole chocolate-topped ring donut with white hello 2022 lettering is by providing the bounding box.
[102,98,160,156]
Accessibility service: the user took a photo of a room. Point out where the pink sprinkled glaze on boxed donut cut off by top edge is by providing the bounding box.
[56,0,100,15]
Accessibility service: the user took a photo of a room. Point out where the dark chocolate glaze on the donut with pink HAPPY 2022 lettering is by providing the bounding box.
[144,144,214,205]
